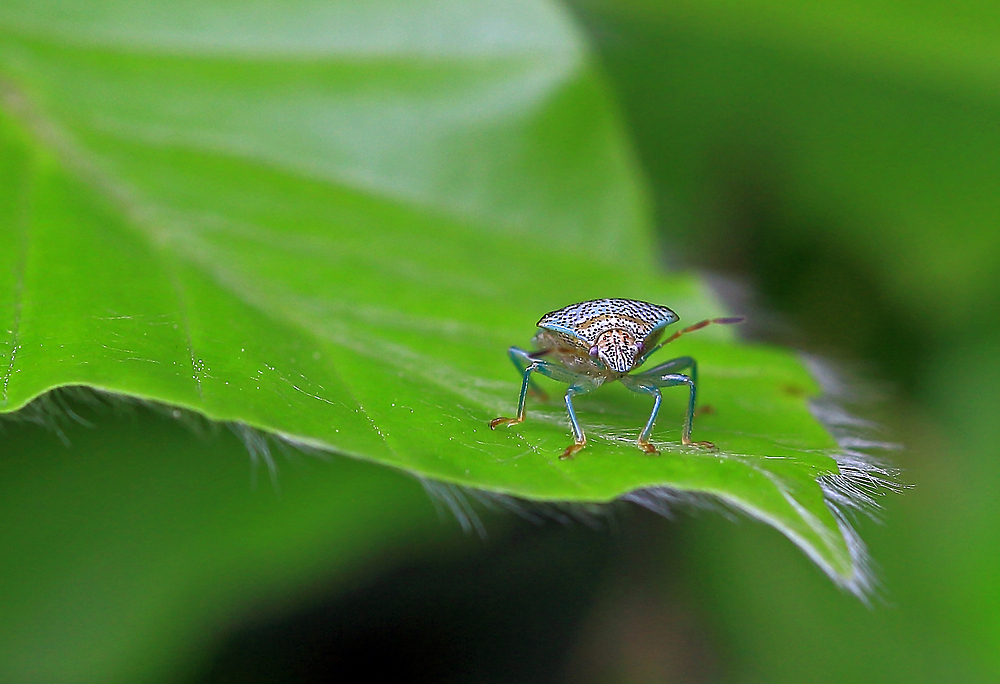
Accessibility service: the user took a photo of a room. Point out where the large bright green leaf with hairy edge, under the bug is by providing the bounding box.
[0,1,861,586]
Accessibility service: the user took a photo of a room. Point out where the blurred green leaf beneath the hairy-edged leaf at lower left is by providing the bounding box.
[0,401,454,682]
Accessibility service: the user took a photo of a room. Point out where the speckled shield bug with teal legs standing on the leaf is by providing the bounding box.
[490,299,743,459]
